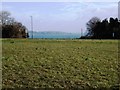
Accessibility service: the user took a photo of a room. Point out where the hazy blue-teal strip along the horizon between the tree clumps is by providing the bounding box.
[29,31,80,39]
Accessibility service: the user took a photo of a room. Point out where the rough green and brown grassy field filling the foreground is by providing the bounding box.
[2,39,118,88]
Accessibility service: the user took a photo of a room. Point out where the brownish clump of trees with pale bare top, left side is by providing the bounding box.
[0,11,29,38]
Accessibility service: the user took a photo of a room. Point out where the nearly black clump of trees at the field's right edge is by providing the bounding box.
[81,17,120,39]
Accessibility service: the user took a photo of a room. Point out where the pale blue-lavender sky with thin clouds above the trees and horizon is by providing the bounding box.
[2,0,118,33]
